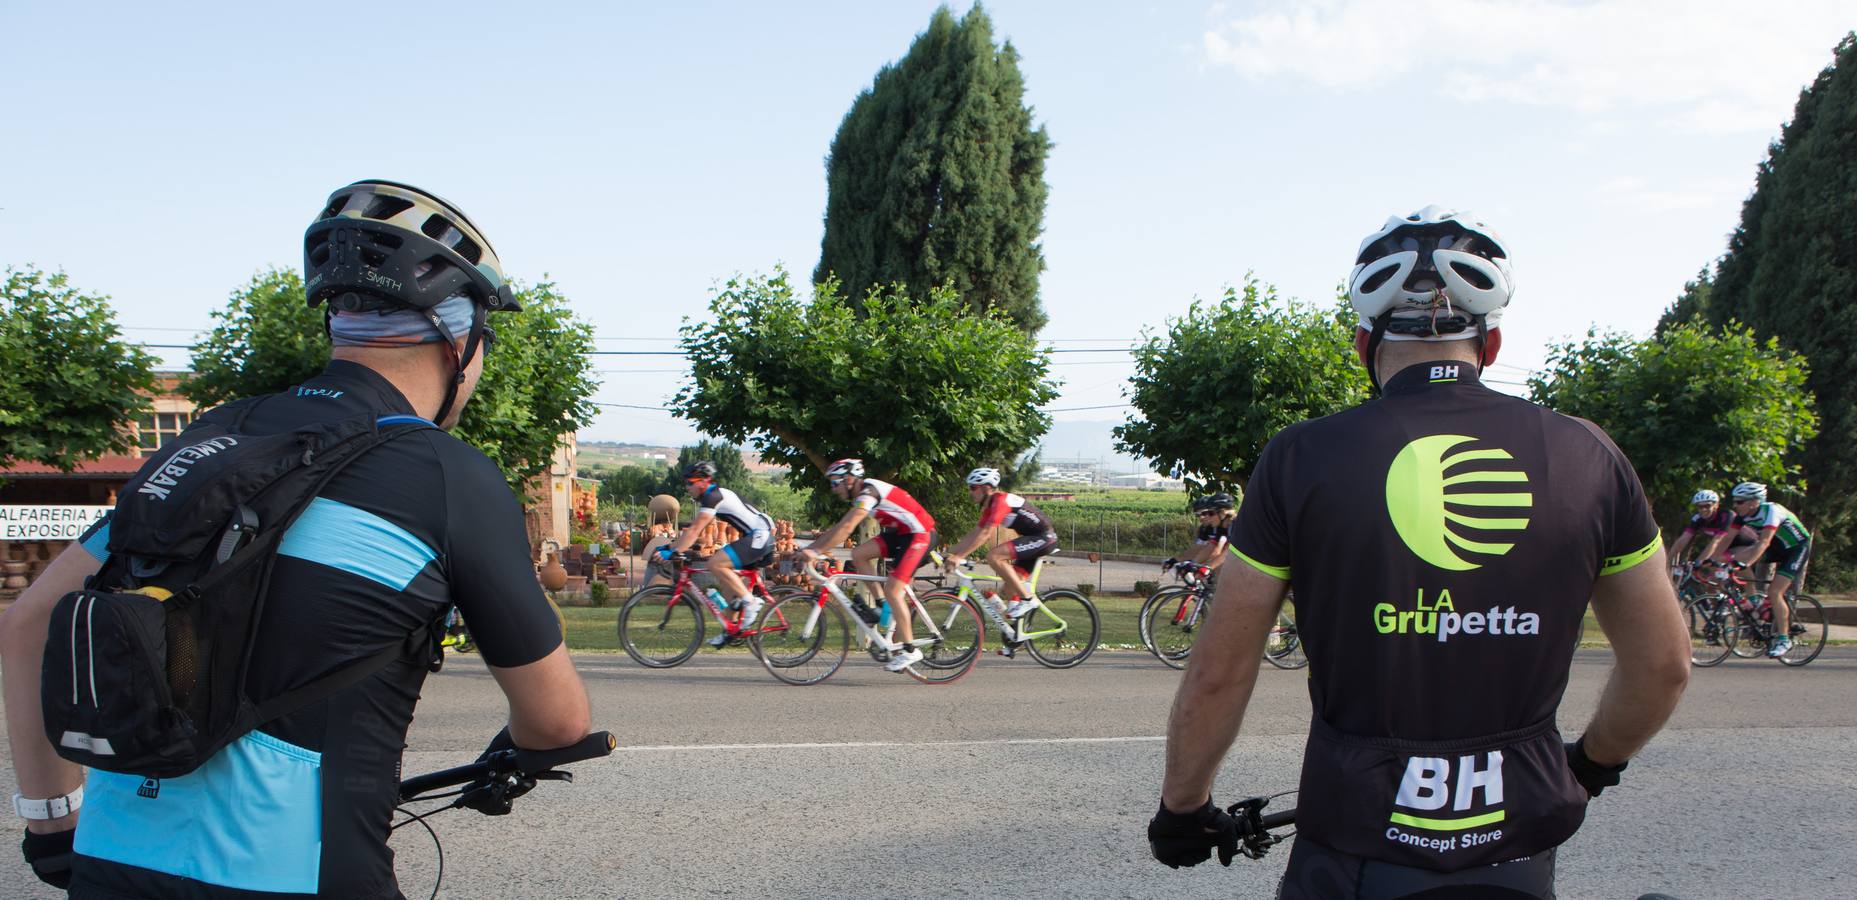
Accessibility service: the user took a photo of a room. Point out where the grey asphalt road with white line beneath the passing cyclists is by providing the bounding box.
[0,648,1857,898]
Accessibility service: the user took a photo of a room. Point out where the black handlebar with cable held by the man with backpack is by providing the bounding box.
[388,731,618,898]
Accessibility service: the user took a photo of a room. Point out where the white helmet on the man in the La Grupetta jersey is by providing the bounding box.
[1348,206,1515,341]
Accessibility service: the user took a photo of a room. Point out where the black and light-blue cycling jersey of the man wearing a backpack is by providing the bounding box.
[71,360,561,900]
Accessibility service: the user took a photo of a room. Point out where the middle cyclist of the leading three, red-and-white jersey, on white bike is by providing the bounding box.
[802,458,934,672]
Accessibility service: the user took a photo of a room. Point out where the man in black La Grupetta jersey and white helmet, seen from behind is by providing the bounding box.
[1148,208,1688,900]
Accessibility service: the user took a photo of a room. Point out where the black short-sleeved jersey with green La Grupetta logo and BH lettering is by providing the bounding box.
[1231,362,1660,870]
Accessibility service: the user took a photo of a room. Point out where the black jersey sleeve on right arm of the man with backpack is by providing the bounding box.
[446,444,561,668]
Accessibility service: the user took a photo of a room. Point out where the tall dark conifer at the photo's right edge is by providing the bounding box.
[1707,33,1857,541]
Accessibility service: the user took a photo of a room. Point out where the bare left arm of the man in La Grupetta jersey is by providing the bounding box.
[1161,566,1292,813]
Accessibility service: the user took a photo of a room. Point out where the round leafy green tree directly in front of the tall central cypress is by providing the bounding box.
[672,271,1057,519]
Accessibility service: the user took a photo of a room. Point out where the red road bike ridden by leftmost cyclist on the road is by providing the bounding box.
[618,557,800,668]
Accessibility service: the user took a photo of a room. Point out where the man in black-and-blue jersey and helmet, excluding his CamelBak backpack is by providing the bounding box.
[0,182,589,900]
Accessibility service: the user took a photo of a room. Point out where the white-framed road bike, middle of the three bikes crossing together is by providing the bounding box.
[748,564,986,685]
